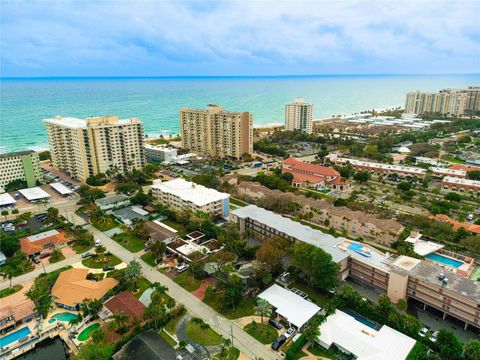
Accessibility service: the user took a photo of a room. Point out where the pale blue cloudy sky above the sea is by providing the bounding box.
[0,0,480,77]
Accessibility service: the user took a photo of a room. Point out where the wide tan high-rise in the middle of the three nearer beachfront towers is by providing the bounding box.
[180,104,253,159]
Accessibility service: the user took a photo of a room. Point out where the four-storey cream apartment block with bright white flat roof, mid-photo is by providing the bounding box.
[152,178,230,218]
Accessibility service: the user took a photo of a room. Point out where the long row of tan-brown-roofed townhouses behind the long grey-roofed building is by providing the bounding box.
[235,182,404,246]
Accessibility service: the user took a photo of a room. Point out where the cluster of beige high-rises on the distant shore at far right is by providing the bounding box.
[405,86,480,116]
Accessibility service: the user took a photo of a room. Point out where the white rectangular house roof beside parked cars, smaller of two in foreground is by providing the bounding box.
[258,284,321,328]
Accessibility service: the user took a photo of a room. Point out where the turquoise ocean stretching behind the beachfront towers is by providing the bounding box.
[0,74,480,152]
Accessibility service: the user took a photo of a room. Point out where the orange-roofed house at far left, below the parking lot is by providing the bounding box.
[20,230,72,256]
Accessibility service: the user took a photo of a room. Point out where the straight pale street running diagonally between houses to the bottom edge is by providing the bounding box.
[85,225,280,360]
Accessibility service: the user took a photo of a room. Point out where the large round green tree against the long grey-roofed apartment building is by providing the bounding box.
[293,242,339,290]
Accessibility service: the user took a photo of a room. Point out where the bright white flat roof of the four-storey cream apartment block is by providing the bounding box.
[152,178,230,206]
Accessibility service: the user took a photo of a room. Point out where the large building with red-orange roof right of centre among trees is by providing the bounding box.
[282,158,350,191]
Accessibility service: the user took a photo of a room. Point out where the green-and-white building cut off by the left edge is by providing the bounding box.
[0,150,43,188]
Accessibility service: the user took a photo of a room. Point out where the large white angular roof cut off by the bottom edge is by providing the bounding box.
[317,310,416,360]
